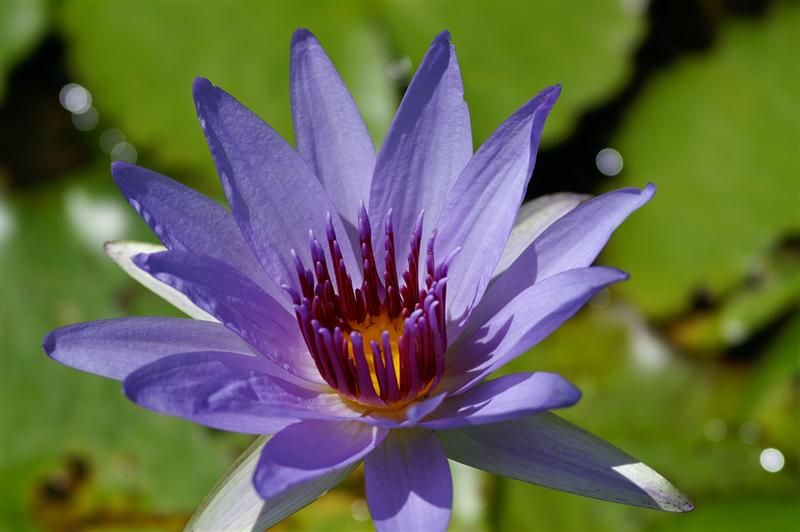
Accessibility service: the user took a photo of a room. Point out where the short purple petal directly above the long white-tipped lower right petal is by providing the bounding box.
[421,372,581,429]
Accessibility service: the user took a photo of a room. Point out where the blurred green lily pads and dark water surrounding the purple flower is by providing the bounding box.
[0,0,800,532]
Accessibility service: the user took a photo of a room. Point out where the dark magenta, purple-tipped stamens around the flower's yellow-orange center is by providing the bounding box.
[284,205,452,409]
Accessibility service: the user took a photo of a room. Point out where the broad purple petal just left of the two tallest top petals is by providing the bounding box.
[194,78,361,286]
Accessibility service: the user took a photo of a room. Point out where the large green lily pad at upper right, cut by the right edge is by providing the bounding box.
[605,2,800,318]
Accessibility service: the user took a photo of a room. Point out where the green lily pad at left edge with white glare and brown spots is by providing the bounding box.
[0,167,242,530]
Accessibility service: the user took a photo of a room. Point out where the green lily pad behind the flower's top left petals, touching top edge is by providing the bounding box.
[60,2,396,183]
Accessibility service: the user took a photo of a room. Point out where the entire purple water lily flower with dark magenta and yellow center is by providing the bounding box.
[44,30,692,530]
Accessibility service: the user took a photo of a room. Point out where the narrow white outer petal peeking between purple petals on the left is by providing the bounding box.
[103,240,217,321]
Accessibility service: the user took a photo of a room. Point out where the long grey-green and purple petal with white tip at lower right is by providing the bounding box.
[438,413,694,512]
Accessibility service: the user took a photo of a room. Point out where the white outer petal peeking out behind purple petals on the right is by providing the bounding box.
[494,192,591,277]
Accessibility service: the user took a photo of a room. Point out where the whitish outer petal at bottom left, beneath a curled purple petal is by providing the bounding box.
[186,436,356,532]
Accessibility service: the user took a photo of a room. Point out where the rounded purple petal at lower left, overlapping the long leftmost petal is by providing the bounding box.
[123,352,359,434]
